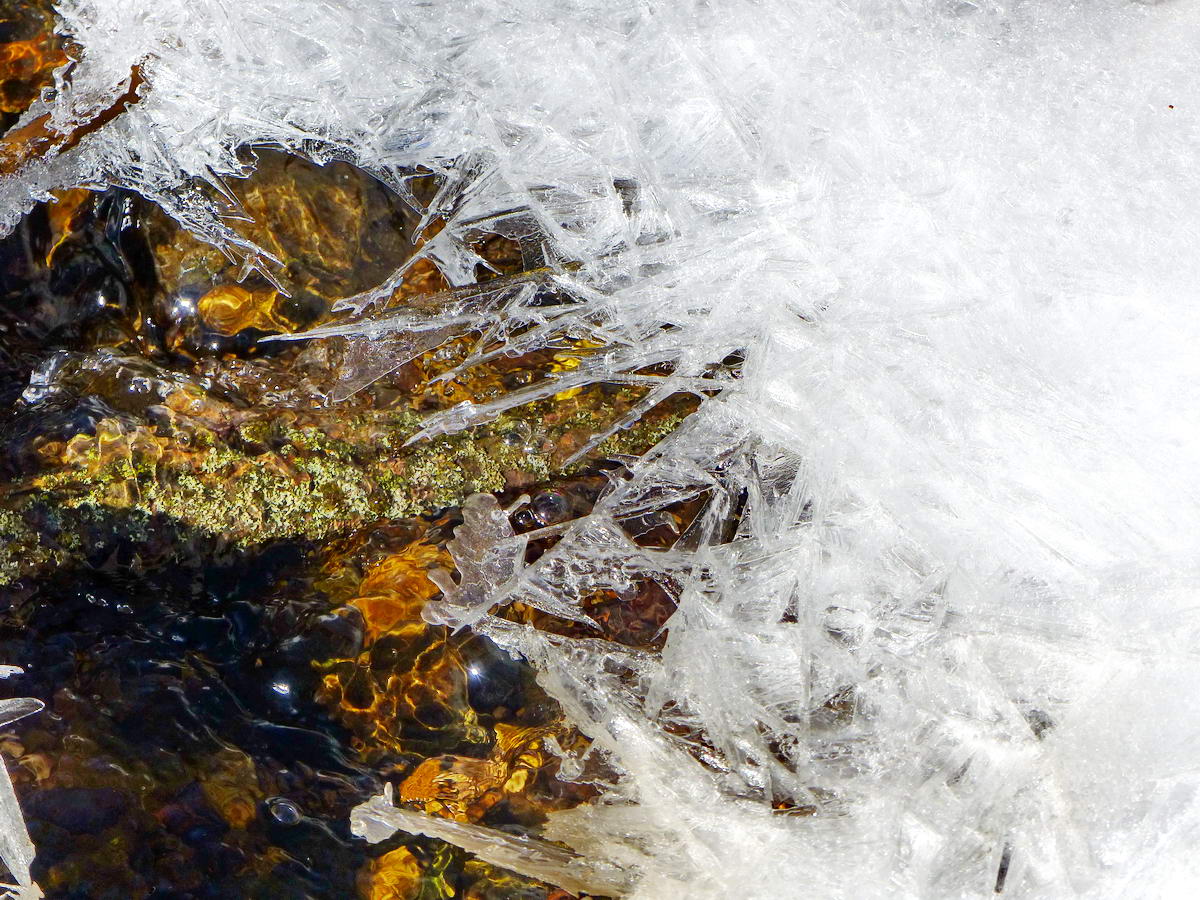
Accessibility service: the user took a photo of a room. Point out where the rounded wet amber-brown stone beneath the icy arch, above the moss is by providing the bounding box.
[145,148,427,355]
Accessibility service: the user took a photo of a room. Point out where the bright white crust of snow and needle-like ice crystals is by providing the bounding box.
[11,0,1200,899]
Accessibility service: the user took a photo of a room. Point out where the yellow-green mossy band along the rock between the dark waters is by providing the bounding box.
[0,395,691,583]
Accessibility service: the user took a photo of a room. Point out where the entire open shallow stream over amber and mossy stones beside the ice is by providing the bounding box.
[0,112,688,900]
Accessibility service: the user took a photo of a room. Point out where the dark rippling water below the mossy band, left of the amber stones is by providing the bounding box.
[0,547,379,898]
